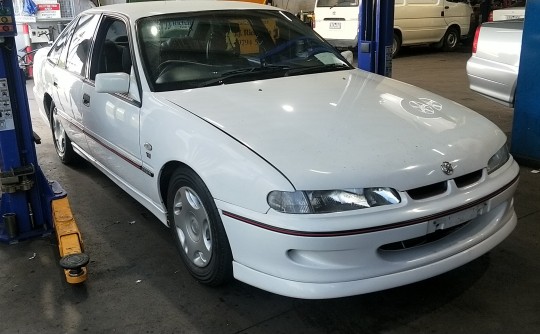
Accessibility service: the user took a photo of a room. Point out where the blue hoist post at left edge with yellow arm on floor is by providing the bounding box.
[0,0,89,283]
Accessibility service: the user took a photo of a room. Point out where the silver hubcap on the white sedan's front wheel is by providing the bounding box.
[173,187,212,268]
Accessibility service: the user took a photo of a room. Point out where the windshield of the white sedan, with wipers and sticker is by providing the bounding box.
[137,10,352,92]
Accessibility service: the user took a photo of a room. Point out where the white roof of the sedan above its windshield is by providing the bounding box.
[86,0,278,21]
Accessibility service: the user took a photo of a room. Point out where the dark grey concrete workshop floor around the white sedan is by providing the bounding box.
[0,48,540,334]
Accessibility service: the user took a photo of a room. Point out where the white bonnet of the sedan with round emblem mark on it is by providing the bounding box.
[157,70,506,190]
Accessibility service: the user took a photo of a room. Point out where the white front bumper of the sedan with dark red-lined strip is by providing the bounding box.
[218,159,519,299]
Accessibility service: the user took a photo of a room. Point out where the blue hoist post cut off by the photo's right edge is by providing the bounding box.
[511,0,540,168]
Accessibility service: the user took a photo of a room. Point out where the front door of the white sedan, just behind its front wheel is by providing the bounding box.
[82,18,149,196]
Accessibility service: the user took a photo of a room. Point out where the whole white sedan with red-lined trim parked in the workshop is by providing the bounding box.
[34,1,519,298]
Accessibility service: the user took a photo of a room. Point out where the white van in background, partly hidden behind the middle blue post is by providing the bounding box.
[314,0,473,55]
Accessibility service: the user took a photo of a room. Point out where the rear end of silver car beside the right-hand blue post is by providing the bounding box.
[467,19,523,107]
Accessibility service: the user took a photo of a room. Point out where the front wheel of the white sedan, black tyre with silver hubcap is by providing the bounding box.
[167,168,232,286]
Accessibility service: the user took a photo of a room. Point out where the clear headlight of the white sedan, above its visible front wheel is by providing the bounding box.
[267,188,401,213]
